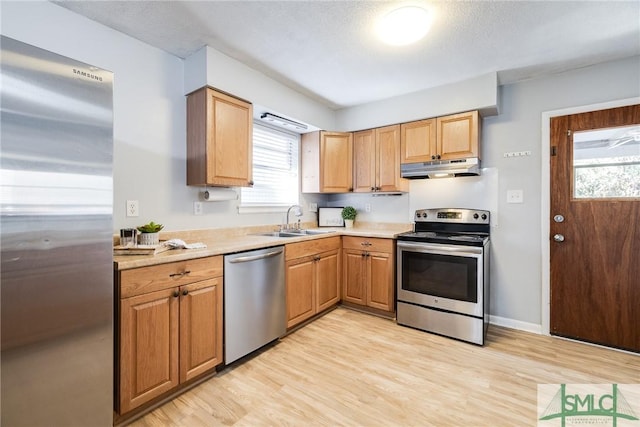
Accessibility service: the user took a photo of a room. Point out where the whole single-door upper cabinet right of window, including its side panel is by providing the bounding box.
[301,131,353,193]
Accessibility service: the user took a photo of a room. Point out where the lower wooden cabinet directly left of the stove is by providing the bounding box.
[342,236,395,313]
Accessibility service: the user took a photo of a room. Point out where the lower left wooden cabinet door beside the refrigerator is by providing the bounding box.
[119,288,179,413]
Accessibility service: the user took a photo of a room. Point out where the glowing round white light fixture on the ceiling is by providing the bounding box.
[377,6,431,46]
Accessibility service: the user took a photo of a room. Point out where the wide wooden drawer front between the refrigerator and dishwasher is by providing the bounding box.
[120,256,223,298]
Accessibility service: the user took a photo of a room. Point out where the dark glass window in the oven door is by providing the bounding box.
[402,251,478,303]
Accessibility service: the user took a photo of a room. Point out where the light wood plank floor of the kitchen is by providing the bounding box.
[132,308,640,427]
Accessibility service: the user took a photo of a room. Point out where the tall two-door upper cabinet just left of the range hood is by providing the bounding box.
[353,125,409,193]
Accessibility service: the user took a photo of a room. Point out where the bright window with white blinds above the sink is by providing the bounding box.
[240,123,300,208]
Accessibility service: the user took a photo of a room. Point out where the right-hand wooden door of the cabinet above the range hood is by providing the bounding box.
[436,111,480,160]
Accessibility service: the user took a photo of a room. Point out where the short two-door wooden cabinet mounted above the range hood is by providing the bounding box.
[400,111,480,163]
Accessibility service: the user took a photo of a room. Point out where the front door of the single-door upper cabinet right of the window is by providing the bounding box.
[320,131,353,193]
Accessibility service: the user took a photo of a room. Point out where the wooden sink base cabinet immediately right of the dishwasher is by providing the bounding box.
[286,237,340,328]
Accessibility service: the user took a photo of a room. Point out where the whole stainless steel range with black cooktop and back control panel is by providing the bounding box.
[397,209,490,345]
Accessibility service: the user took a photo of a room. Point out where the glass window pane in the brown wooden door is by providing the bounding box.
[573,125,640,199]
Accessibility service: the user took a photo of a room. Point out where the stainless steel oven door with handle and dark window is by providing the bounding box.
[397,241,484,317]
